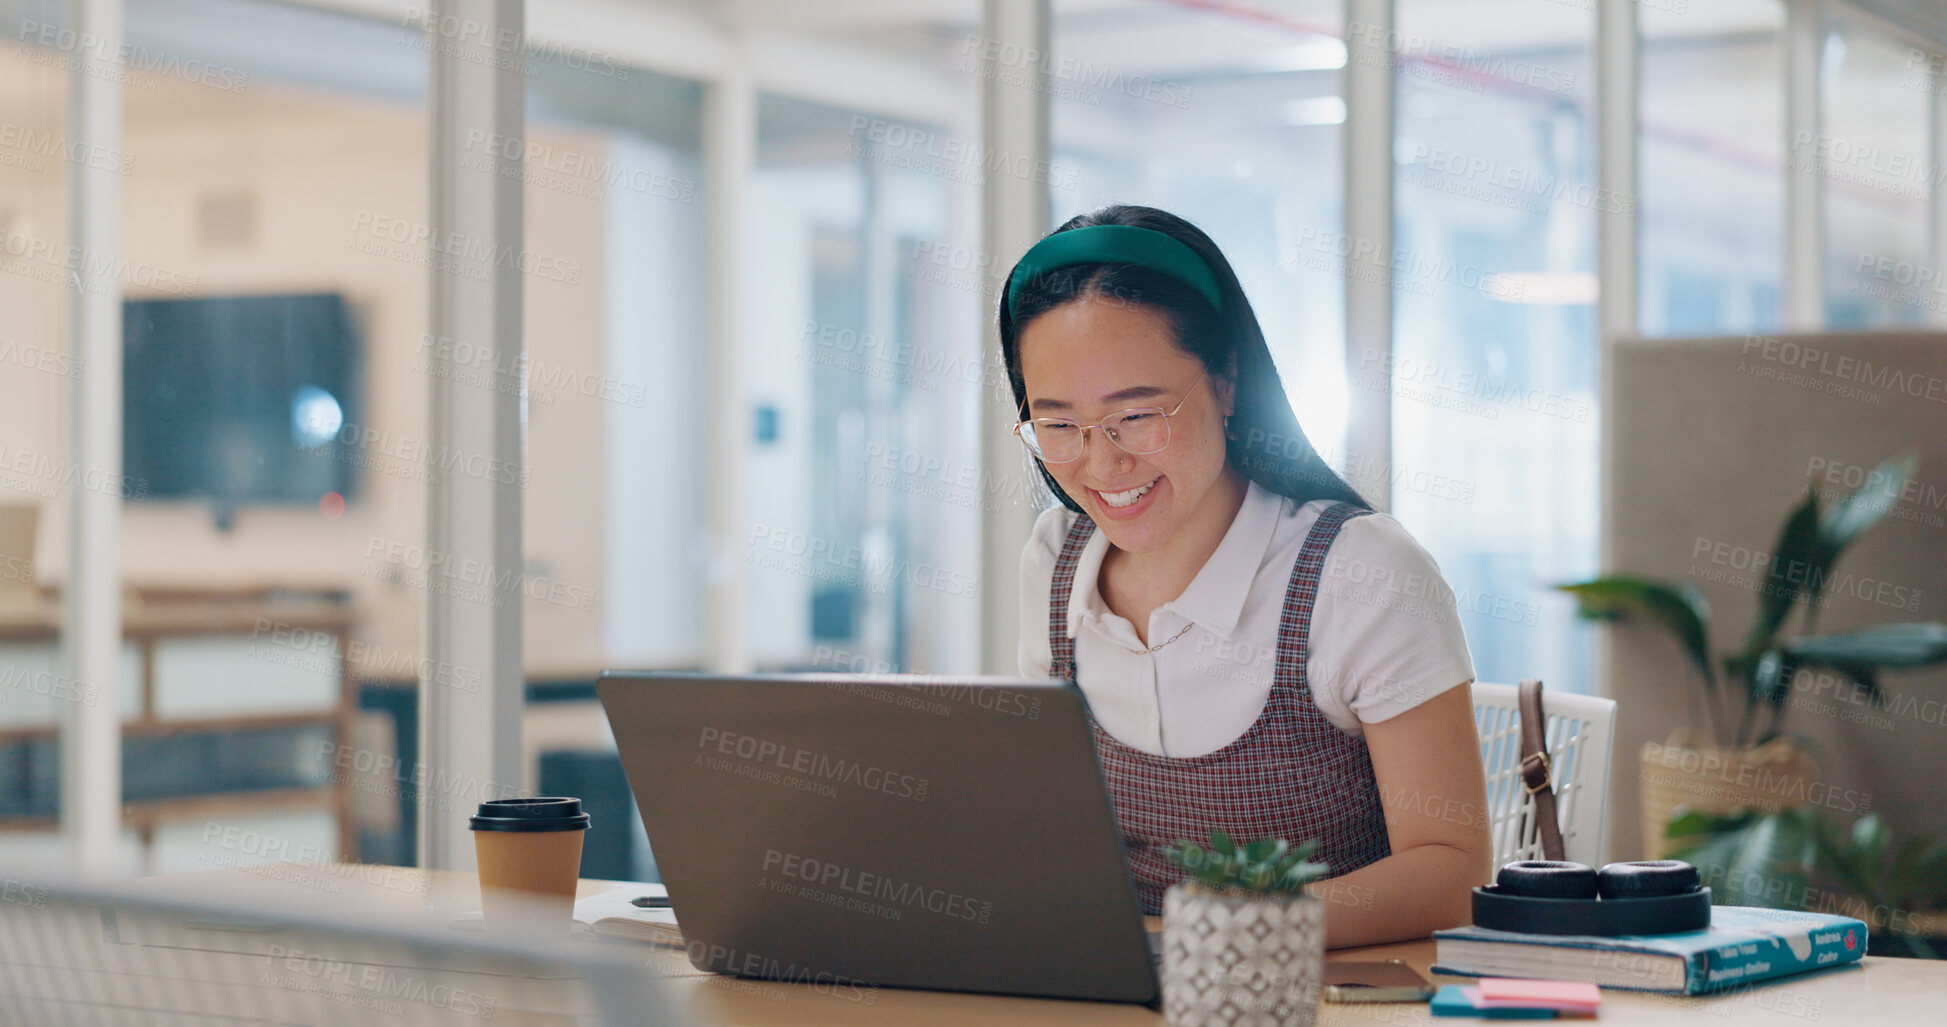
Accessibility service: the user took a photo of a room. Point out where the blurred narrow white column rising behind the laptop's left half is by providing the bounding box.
[703,64,759,674]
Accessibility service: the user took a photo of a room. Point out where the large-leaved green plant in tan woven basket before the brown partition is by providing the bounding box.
[1558,452,1947,857]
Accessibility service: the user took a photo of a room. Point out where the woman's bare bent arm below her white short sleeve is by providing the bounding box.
[1306,686,1491,949]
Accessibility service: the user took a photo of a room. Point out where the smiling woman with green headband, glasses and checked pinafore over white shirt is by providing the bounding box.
[1001,207,1489,947]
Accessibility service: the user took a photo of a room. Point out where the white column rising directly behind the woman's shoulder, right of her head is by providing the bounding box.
[1343,0,1394,511]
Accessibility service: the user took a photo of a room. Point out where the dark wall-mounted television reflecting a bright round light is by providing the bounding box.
[123,292,364,524]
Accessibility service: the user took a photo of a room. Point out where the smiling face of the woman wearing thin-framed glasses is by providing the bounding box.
[1020,296,1231,553]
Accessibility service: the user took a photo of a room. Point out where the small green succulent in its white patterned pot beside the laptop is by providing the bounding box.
[1162,830,1328,1027]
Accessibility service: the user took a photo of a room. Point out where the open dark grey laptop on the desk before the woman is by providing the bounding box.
[596,672,1160,1006]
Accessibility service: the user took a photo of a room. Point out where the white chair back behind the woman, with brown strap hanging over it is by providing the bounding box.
[1474,682,1616,869]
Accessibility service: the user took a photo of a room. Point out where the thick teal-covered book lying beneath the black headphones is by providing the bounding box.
[1433,906,1865,996]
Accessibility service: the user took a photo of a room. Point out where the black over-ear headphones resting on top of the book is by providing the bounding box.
[1474,859,1709,937]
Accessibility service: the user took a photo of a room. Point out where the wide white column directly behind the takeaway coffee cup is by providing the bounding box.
[419,0,528,869]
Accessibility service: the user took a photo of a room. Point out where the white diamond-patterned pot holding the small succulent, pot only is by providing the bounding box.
[1162,881,1326,1027]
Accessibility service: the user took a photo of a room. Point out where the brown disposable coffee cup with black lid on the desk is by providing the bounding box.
[467,797,588,932]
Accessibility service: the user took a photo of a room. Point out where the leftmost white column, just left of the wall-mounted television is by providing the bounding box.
[60,0,123,877]
